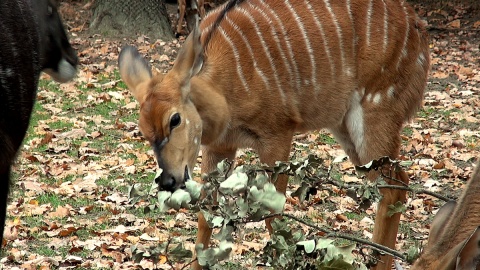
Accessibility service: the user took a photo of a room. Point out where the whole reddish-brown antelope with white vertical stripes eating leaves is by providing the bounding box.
[119,0,429,269]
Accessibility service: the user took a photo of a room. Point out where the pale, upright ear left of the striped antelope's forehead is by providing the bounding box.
[118,46,152,104]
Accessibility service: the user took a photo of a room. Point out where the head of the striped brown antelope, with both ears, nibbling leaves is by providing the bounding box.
[119,29,202,192]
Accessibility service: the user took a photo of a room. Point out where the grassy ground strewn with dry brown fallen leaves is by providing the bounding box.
[0,1,480,269]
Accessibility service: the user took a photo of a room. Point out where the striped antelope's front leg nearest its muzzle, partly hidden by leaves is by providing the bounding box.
[192,147,237,270]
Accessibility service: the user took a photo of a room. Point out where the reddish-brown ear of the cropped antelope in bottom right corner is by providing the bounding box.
[455,227,480,270]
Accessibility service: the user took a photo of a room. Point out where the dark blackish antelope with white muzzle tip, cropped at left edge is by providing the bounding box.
[0,0,78,247]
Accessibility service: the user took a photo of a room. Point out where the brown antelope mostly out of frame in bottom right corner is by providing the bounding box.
[411,162,480,270]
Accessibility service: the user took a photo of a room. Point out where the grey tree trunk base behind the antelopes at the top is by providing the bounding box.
[91,0,173,40]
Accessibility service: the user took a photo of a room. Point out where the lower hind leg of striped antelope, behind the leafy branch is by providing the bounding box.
[369,169,409,270]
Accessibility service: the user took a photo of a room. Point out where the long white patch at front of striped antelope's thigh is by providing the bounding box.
[346,91,364,156]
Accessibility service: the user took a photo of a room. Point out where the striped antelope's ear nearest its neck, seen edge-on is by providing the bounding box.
[170,24,203,88]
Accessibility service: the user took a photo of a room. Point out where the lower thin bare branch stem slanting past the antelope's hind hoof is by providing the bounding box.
[262,213,406,261]
